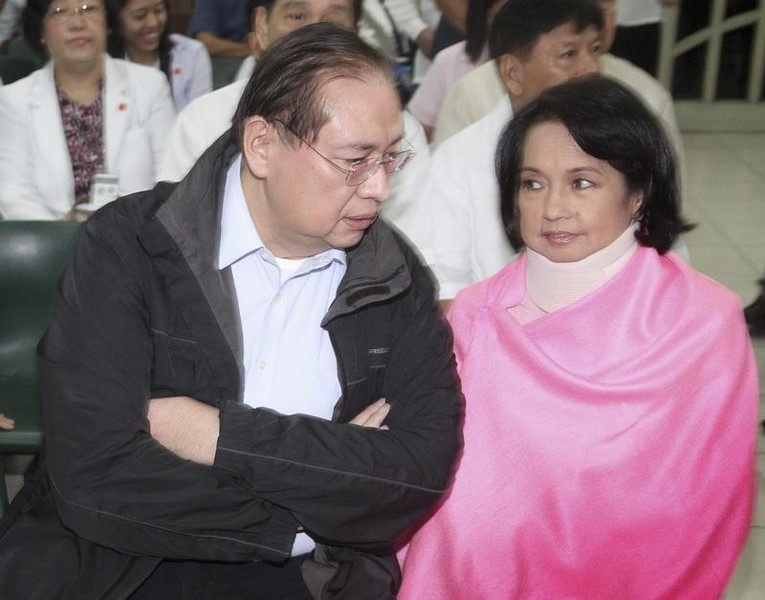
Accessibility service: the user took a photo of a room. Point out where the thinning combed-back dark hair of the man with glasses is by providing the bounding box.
[232,23,396,150]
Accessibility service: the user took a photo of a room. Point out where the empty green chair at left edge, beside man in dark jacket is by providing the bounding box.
[0,221,81,516]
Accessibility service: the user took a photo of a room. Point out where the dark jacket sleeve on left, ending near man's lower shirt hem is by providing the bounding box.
[38,214,297,561]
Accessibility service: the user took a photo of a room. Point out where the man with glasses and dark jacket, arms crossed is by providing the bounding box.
[0,24,461,600]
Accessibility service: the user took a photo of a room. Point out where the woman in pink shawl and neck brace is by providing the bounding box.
[399,76,758,600]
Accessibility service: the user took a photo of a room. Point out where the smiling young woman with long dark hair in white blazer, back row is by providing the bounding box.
[108,0,212,112]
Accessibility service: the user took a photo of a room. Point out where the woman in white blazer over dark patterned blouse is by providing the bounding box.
[0,0,175,219]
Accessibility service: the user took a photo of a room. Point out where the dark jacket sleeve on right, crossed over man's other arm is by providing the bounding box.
[215,240,462,548]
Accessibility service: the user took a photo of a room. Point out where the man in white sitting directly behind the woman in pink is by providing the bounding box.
[424,0,603,300]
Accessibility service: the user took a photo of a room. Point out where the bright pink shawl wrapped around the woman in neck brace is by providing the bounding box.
[399,247,758,600]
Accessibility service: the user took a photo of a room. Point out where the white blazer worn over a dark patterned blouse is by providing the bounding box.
[0,55,175,219]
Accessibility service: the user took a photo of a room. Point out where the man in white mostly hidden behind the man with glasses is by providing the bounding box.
[160,0,430,260]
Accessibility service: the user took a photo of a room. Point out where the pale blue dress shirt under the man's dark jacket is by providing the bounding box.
[218,155,346,556]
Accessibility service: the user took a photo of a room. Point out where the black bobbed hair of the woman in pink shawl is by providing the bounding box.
[495,75,693,254]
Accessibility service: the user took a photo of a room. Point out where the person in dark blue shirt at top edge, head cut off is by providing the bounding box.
[189,0,250,58]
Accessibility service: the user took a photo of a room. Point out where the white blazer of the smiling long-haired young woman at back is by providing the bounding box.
[170,33,212,112]
